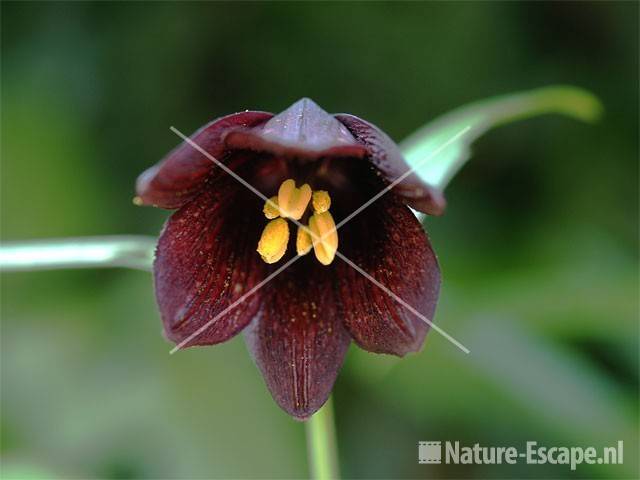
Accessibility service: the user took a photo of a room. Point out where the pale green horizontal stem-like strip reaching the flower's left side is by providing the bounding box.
[0,235,157,272]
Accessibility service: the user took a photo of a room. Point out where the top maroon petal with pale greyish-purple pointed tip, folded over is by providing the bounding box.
[225,98,367,158]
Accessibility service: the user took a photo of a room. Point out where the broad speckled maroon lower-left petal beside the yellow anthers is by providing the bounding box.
[154,179,265,346]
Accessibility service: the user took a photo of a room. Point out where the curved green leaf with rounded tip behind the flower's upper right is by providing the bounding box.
[400,86,603,188]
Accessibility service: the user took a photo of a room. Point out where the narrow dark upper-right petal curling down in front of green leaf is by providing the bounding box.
[336,114,446,215]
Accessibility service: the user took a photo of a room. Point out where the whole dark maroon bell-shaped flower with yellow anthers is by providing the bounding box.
[136,98,444,419]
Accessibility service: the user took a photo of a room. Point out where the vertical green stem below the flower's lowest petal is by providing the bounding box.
[305,397,340,480]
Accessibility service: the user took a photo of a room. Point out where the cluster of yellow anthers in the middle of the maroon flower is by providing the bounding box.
[257,179,338,265]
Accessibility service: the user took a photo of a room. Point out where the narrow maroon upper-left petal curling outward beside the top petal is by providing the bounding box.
[136,111,273,208]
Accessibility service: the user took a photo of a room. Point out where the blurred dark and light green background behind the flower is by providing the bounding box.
[1,2,640,479]
